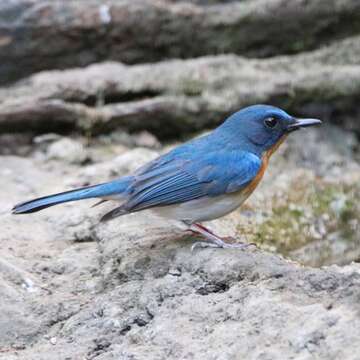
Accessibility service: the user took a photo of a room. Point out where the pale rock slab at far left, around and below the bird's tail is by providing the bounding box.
[0,156,104,352]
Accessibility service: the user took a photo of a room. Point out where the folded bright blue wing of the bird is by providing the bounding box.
[122,151,261,212]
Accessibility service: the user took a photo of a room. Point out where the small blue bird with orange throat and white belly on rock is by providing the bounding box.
[12,104,321,249]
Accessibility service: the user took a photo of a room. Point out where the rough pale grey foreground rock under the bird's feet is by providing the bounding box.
[4,225,360,359]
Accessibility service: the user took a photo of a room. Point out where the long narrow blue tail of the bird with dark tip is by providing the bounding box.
[12,176,132,214]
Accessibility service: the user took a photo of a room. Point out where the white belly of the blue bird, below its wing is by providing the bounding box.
[151,192,249,223]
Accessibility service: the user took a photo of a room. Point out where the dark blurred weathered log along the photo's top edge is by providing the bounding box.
[0,0,360,83]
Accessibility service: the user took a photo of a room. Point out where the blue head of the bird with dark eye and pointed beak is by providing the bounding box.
[219,105,321,154]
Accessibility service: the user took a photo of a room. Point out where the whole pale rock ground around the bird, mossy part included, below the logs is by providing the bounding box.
[0,127,360,360]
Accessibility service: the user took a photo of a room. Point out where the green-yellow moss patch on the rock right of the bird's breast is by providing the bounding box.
[248,183,360,255]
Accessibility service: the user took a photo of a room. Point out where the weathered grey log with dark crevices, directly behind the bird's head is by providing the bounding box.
[0,37,360,138]
